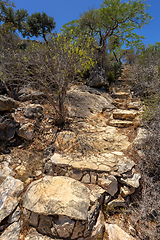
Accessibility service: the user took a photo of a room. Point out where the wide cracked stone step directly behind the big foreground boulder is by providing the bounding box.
[44,152,135,185]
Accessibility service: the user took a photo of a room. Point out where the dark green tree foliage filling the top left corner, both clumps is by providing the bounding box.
[0,0,55,42]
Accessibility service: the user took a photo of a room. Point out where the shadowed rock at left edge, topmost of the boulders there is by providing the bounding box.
[0,95,19,112]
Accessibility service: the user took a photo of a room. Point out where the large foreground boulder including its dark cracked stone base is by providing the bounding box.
[23,176,104,239]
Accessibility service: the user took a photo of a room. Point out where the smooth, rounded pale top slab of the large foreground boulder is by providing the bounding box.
[23,176,90,220]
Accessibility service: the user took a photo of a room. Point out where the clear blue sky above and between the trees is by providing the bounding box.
[14,0,160,45]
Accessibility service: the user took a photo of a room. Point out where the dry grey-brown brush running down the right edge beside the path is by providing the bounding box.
[130,44,160,240]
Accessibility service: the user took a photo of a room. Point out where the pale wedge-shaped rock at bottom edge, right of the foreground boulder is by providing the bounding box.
[105,223,134,240]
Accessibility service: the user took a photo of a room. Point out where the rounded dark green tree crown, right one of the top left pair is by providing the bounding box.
[23,12,55,42]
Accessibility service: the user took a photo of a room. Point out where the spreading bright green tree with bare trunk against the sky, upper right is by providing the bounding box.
[62,0,152,67]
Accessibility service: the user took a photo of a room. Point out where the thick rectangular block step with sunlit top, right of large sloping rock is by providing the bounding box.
[113,109,137,120]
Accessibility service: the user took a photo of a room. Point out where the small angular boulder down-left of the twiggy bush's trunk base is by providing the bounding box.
[17,123,34,140]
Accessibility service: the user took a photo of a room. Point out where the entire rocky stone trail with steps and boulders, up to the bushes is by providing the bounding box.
[0,68,145,240]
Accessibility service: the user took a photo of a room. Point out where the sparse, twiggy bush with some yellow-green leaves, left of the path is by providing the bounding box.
[1,35,94,125]
